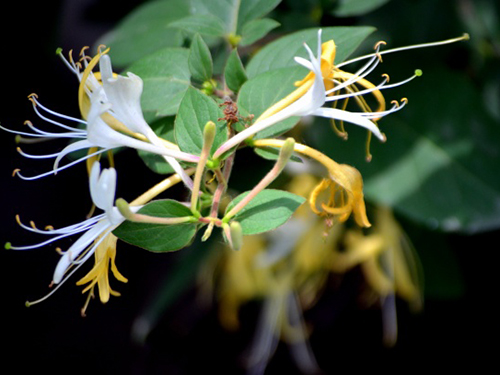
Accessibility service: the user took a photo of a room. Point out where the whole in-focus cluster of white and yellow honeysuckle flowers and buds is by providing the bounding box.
[1,30,464,326]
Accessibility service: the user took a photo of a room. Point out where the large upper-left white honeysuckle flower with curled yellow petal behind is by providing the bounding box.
[2,51,199,188]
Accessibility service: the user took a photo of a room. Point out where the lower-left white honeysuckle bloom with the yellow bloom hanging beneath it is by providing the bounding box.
[6,162,142,304]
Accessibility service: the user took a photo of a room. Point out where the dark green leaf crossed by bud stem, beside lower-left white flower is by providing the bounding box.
[113,199,197,253]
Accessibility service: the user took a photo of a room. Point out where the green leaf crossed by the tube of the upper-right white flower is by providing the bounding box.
[238,66,307,139]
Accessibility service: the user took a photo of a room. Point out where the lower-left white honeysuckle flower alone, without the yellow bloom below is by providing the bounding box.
[5,162,142,304]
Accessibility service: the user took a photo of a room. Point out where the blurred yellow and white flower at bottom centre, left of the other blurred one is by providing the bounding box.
[205,232,317,373]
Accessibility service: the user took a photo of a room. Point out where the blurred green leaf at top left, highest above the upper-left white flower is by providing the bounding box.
[96,0,189,67]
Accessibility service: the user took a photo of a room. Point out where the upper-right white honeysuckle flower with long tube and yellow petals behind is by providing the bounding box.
[214,30,421,157]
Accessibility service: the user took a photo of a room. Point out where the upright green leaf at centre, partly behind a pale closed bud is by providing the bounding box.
[174,87,227,155]
